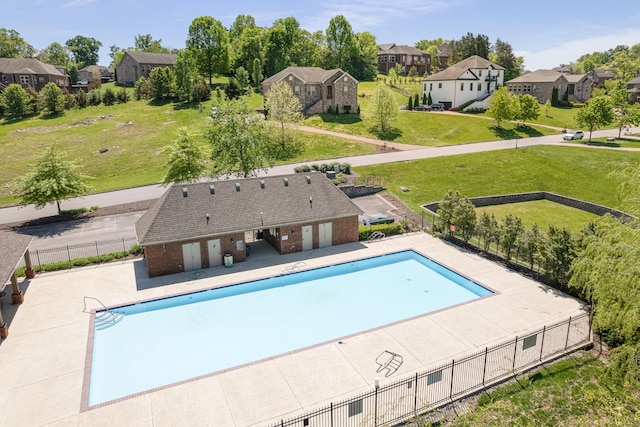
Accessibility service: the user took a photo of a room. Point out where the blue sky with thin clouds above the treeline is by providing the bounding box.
[0,0,640,71]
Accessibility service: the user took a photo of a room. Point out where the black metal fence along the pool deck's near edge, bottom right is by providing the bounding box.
[273,313,591,427]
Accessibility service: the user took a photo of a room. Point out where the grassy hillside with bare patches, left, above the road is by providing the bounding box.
[0,96,376,205]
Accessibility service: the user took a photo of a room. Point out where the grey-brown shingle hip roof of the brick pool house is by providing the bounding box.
[136,172,362,246]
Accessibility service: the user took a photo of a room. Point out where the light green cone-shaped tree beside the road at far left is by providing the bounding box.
[16,145,89,215]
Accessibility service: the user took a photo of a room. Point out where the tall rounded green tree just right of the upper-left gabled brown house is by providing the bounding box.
[186,16,229,84]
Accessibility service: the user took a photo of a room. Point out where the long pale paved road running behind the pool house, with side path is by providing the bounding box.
[0,128,632,224]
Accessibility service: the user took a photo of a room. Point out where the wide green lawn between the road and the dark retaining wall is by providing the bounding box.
[355,146,640,212]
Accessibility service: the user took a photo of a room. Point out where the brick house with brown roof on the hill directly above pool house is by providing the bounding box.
[262,67,358,115]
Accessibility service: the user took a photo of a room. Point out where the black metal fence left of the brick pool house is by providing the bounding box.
[18,237,138,269]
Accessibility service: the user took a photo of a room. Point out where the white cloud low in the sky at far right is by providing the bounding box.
[514,28,640,71]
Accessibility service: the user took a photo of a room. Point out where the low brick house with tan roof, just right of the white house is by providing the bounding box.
[505,70,594,104]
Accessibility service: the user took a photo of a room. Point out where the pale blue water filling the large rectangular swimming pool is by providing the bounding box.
[88,251,492,406]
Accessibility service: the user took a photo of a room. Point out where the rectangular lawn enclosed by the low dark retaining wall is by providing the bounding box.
[476,200,598,233]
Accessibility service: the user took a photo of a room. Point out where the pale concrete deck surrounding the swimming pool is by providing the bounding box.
[0,233,585,427]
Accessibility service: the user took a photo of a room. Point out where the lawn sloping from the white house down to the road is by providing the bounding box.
[304,82,558,147]
